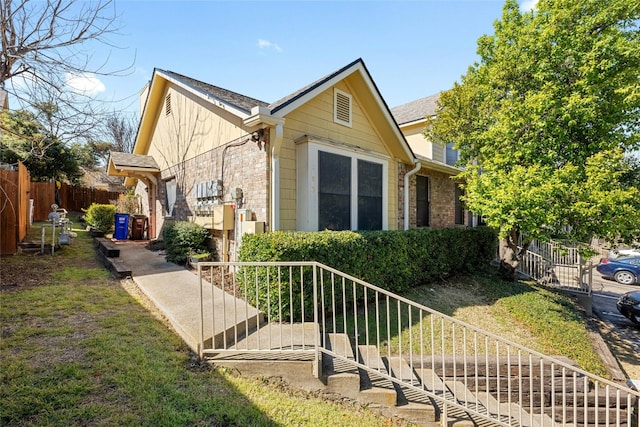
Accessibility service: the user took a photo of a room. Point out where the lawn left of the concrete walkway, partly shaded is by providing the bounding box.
[0,225,404,426]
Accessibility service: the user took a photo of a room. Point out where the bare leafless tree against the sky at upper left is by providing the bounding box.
[0,0,126,152]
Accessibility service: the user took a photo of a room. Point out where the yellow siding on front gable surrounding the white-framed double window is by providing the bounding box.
[280,82,398,230]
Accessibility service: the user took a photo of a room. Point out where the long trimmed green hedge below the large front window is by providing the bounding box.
[239,227,498,317]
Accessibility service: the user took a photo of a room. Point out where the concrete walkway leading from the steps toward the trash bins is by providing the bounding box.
[113,240,258,354]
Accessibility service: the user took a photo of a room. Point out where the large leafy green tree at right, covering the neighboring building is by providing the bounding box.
[425,0,640,278]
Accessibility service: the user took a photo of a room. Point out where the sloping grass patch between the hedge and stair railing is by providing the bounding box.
[337,271,610,378]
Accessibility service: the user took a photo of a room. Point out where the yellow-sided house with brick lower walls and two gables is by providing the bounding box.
[108,59,472,260]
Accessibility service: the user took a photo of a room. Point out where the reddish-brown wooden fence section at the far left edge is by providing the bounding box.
[0,163,30,255]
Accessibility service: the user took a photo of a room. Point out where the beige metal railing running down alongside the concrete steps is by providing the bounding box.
[198,262,640,426]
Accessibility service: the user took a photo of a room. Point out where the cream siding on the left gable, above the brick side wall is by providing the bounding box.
[148,86,248,169]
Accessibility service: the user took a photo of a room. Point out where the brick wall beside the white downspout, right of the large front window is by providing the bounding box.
[398,164,466,230]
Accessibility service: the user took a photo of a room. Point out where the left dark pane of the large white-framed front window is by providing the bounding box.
[318,151,351,230]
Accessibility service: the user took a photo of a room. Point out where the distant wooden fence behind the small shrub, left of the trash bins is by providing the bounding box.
[31,182,120,221]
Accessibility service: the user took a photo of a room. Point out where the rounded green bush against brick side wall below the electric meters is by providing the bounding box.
[162,221,210,264]
